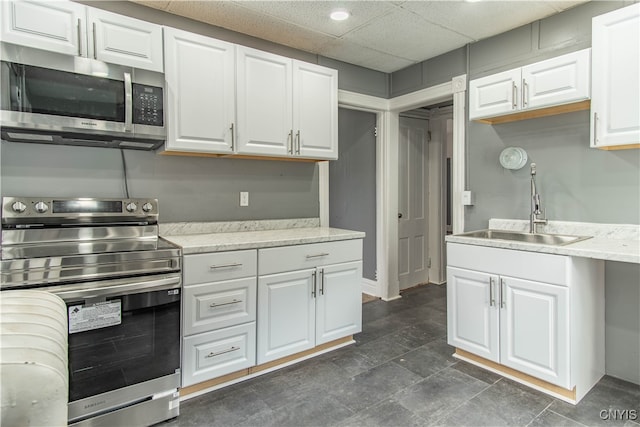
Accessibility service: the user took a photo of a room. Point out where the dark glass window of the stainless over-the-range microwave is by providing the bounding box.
[2,63,125,123]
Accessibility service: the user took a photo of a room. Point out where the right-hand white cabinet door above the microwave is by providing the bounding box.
[87,7,163,73]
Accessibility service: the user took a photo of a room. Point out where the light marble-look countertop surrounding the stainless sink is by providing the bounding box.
[446,219,640,264]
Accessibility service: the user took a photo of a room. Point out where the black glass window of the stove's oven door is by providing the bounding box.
[67,290,180,402]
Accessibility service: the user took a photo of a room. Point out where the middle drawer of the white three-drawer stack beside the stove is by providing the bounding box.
[184,276,257,335]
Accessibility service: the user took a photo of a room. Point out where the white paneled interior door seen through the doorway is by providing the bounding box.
[398,117,429,290]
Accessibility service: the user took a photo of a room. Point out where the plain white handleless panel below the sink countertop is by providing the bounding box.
[447,243,571,286]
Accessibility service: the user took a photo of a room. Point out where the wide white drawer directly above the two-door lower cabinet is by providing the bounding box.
[258,239,362,275]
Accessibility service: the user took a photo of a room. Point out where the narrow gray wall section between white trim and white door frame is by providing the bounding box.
[329,108,376,280]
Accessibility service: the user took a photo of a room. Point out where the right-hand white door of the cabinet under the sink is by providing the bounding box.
[500,277,573,388]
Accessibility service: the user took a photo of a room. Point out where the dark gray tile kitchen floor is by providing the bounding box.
[161,285,640,427]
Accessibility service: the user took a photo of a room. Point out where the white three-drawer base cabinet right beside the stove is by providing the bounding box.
[182,249,257,387]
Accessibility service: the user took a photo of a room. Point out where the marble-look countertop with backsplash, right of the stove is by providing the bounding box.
[160,220,365,255]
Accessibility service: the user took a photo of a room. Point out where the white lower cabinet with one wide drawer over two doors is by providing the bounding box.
[257,239,362,364]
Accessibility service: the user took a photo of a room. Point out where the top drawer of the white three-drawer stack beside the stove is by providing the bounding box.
[183,250,257,286]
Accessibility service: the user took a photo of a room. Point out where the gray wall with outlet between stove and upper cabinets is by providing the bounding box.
[0,141,319,223]
